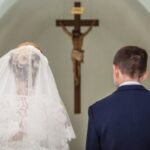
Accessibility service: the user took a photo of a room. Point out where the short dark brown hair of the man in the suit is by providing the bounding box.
[113,46,148,78]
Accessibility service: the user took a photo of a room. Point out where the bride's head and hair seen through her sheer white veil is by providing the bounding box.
[10,42,41,94]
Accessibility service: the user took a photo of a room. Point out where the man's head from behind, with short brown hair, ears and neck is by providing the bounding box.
[113,46,148,85]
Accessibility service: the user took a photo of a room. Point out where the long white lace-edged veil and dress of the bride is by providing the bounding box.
[0,45,75,150]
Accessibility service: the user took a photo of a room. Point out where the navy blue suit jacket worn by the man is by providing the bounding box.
[86,85,150,150]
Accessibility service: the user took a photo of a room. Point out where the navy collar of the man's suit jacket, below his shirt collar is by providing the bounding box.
[117,85,146,92]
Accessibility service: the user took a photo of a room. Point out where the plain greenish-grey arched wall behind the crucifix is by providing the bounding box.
[0,0,150,150]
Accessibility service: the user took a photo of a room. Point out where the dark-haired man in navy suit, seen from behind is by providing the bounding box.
[86,46,150,150]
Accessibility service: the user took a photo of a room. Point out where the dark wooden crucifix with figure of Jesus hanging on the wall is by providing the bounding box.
[56,2,99,113]
